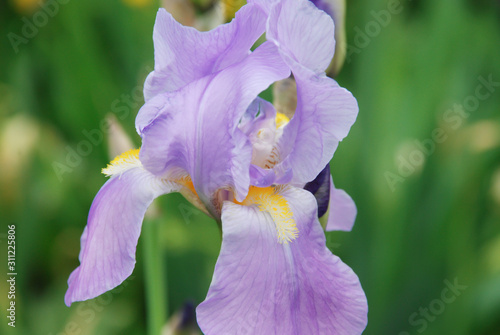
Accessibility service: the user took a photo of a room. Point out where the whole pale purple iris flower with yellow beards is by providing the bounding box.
[65,0,367,335]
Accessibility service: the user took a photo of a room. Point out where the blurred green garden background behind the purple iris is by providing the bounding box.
[0,0,500,335]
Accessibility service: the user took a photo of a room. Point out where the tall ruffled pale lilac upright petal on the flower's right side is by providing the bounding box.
[255,0,358,185]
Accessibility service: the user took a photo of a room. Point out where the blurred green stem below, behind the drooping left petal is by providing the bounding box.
[142,218,168,335]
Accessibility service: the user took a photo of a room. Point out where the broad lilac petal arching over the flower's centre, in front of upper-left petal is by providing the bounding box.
[138,43,290,207]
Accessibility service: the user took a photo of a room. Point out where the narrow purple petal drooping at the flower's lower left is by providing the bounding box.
[64,167,180,306]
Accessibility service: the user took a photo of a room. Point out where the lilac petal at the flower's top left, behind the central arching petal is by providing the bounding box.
[144,5,266,101]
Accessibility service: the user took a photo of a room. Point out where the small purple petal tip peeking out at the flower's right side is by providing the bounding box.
[326,176,358,231]
